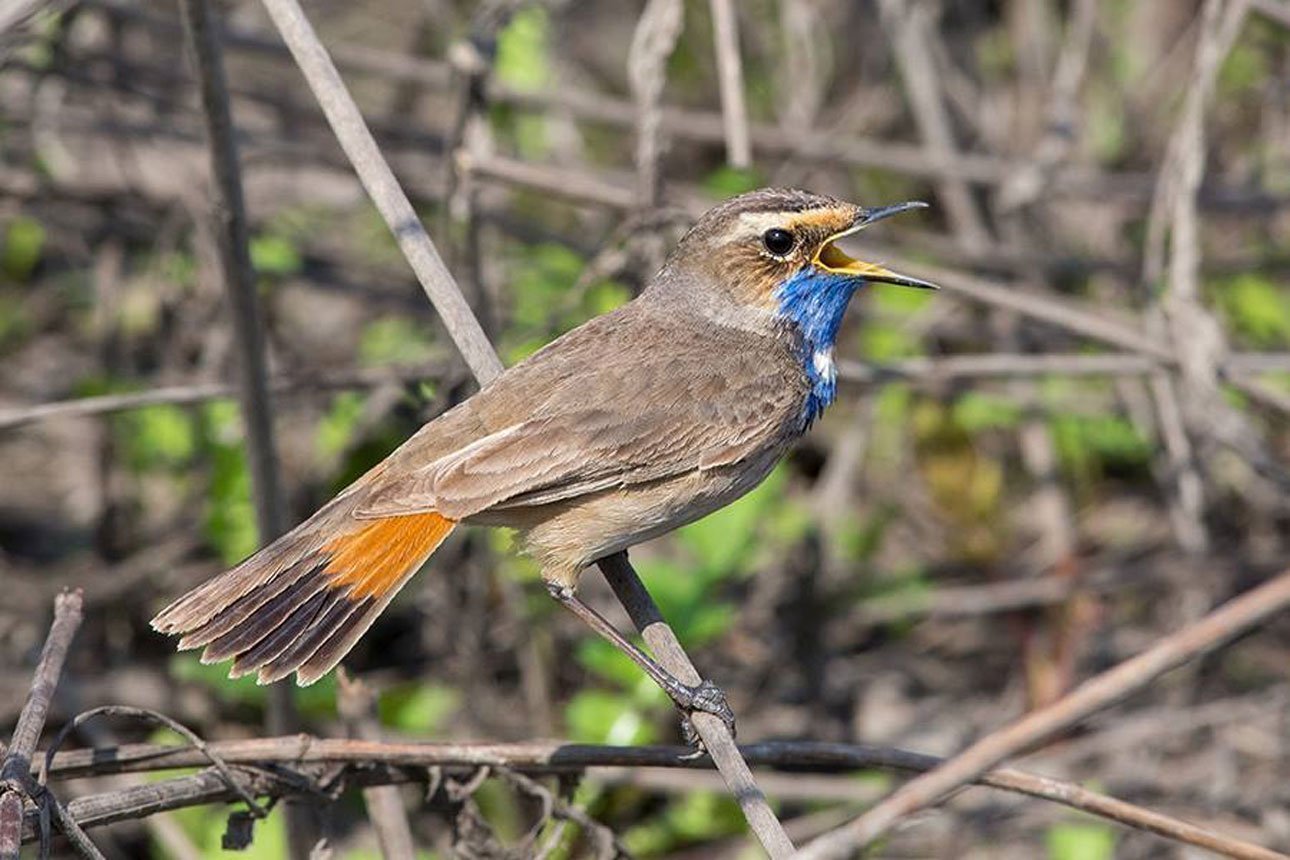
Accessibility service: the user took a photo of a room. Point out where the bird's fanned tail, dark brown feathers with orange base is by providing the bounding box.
[152,495,457,685]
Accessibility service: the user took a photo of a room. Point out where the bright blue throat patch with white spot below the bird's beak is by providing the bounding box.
[775,266,863,428]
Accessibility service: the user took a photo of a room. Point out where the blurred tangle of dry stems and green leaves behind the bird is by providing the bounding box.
[0,0,1290,860]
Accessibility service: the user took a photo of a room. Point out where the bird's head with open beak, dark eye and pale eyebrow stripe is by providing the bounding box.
[662,188,937,317]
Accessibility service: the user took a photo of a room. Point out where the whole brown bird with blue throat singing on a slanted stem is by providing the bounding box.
[152,188,933,719]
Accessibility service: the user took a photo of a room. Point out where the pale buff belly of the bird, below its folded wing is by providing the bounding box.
[471,445,787,585]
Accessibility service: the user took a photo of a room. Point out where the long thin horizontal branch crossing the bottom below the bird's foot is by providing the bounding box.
[27,735,1285,860]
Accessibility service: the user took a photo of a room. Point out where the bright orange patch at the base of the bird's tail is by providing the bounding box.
[323,512,457,601]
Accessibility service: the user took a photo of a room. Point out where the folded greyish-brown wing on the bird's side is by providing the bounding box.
[357,313,806,520]
